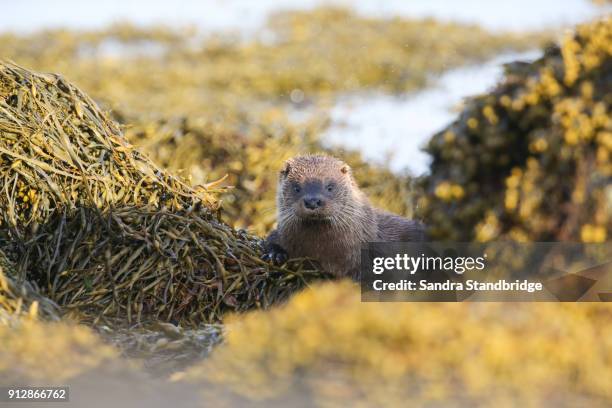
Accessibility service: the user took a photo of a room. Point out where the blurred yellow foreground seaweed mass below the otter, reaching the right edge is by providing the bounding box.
[173,282,612,406]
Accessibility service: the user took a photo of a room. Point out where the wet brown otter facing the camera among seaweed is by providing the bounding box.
[264,154,425,278]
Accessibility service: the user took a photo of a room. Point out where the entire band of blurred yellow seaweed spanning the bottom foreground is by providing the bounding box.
[0,281,612,407]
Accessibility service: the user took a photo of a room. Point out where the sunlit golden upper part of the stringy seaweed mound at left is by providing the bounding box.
[0,64,215,238]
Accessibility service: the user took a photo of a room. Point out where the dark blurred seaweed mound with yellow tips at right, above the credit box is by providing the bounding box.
[422,17,612,242]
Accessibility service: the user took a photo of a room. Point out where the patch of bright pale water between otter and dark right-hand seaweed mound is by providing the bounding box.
[324,51,541,175]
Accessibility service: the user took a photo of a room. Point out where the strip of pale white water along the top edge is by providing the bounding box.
[0,0,611,33]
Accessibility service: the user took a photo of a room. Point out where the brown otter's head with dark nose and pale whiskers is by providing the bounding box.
[277,155,357,222]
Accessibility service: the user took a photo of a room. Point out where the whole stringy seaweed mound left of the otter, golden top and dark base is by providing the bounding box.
[0,63,328,323]
